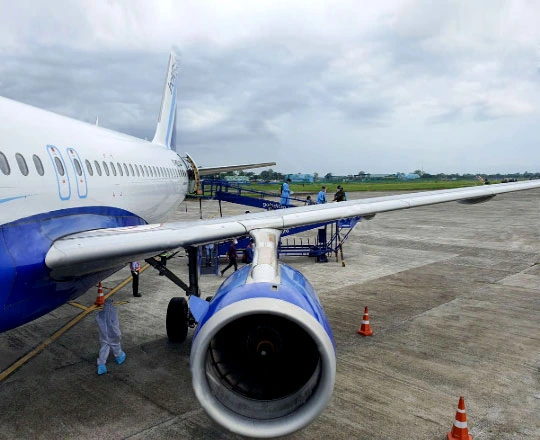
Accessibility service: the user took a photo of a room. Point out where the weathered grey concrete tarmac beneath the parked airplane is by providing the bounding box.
[0,190,540,440]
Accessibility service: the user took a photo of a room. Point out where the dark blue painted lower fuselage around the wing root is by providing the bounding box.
[0,206,145,332]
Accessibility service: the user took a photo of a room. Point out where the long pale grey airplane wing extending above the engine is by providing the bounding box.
[45,180,540,278]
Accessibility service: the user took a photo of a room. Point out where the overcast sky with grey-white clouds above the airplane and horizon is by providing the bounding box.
[0,0,540,175]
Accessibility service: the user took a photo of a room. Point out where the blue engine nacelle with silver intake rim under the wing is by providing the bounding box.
[191,264,336,438]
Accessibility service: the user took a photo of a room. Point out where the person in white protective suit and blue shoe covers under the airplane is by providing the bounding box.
[96,298,126,374]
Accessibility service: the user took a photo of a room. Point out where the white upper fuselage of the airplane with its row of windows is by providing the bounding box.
[0,97,188,225]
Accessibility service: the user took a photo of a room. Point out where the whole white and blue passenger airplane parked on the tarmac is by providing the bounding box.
[0,53,540,438]
